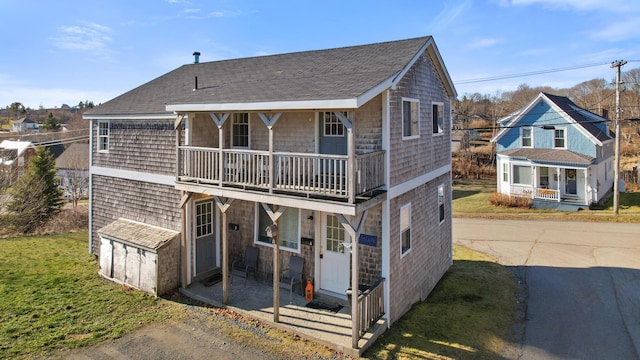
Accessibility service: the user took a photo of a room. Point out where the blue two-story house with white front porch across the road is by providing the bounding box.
[491,93,615,210]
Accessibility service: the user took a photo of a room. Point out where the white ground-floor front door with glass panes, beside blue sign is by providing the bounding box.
[319,214,350,295]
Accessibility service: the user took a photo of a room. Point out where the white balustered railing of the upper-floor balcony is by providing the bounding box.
[176,146,384,203]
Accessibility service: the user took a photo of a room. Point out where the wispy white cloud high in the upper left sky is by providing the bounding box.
[51,23,112,52]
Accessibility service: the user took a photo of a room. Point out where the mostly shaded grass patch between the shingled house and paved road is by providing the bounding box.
[365,246,518,359]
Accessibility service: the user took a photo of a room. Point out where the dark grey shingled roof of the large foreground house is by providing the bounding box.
[86,36,456,116]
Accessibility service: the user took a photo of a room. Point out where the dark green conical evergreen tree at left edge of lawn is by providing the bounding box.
[7,147,62,232]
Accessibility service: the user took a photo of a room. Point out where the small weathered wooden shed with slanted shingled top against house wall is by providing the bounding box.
[98,219,180,296]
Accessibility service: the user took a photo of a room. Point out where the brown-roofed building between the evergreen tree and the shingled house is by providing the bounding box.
[56,143,89,200]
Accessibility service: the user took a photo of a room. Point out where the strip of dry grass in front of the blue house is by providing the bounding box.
[452,179,640,223]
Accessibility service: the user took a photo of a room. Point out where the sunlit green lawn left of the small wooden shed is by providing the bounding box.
[0,232,178,358]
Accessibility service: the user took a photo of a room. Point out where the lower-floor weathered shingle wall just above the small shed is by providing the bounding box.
[91,175,181,255]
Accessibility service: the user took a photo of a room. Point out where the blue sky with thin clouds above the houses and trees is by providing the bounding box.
[0,0,640,108]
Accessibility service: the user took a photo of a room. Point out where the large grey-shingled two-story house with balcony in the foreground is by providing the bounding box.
[84,37,456,354]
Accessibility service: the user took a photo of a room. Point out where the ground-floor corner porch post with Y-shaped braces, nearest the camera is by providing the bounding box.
[335,210,369,349]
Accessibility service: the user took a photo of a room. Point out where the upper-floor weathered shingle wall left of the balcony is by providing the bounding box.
[93,120,176,175]
